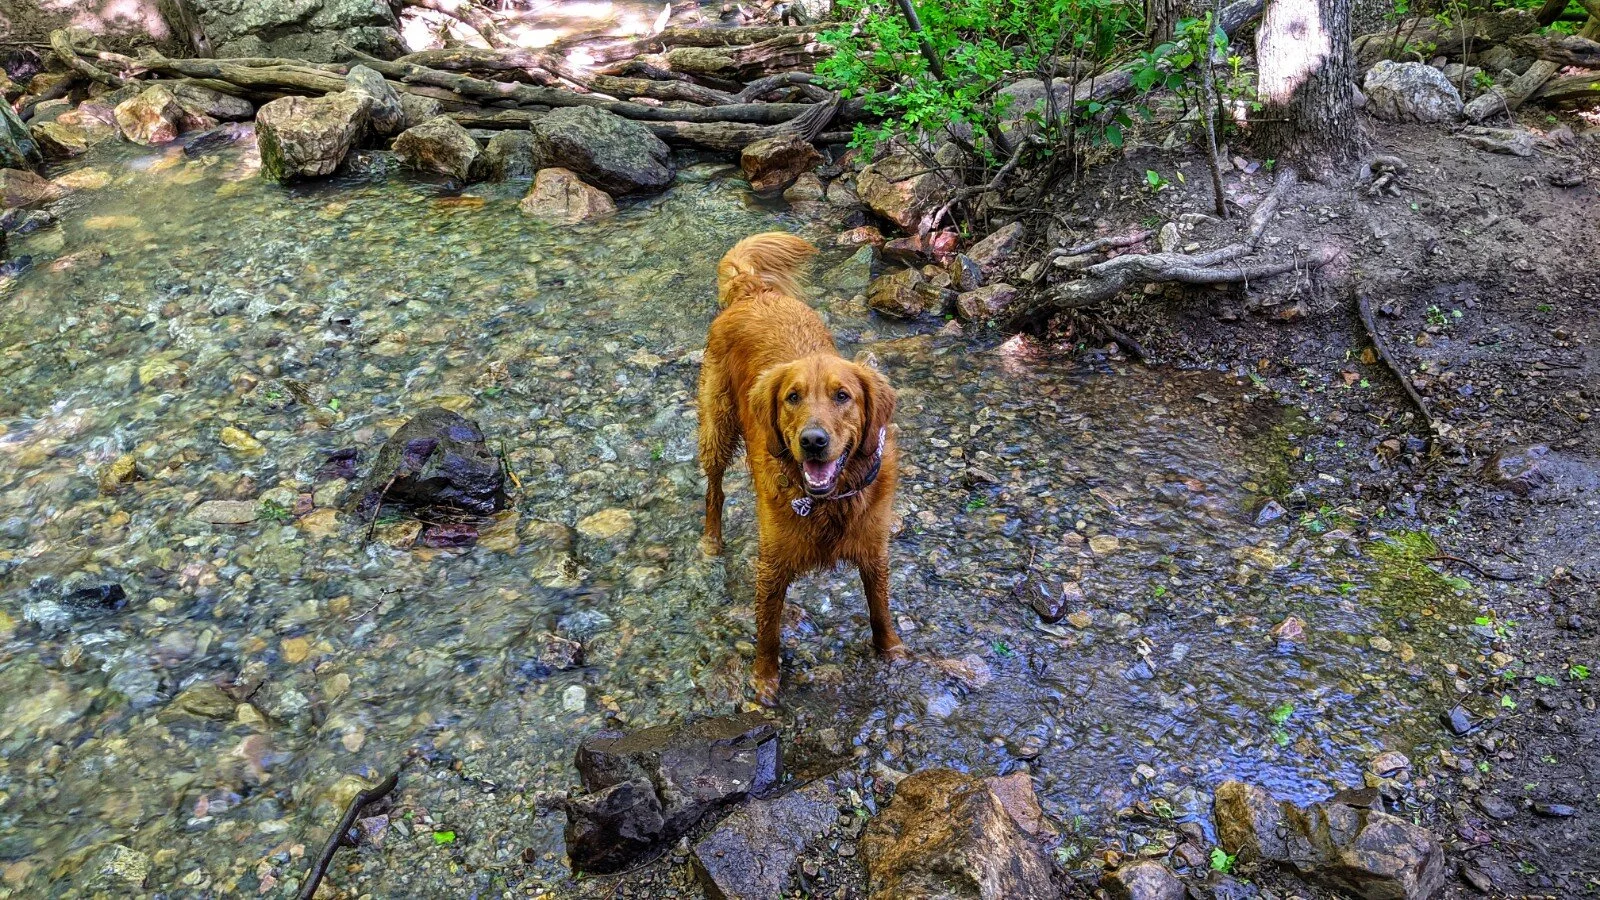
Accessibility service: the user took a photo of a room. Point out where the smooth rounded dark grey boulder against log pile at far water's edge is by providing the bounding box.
[533,106,672,197]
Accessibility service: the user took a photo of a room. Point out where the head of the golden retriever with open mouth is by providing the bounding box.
[750,354,894,496]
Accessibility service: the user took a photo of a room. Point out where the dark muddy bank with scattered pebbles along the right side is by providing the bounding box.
[1030,117,1600,898]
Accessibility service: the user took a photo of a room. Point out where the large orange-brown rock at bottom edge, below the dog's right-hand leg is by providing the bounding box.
[861,769,1059,900]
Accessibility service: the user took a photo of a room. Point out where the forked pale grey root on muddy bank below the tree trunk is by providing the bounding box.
[1016,167,1338,323]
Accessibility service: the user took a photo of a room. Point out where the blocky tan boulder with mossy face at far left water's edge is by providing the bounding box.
[256,91,373,181]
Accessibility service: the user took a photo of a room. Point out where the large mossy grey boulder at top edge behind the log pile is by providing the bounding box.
[189,0,405,62]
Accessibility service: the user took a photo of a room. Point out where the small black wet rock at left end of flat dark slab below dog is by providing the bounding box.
[565,777,666,874]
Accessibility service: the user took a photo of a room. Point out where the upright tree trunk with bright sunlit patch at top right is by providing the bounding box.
[1254,0,1365,178]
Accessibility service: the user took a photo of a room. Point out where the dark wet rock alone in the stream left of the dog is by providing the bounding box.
[355,407,506,520]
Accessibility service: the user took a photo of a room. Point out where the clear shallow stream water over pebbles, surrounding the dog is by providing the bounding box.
[0,138,1472,897]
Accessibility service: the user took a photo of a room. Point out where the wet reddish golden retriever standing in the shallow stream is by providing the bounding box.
[699,232,906,706]
